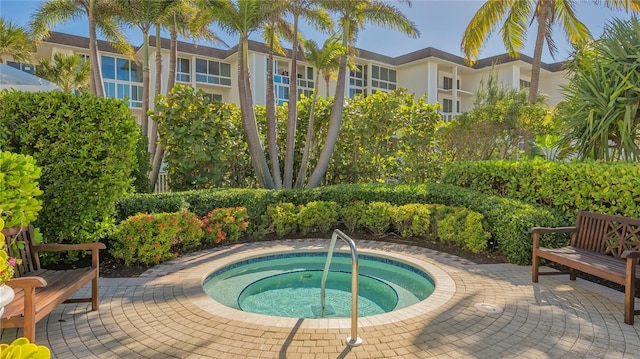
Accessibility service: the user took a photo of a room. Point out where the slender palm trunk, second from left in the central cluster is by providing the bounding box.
[265,28,282,189]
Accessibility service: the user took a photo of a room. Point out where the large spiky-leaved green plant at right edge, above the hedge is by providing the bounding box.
[562,17,640,161]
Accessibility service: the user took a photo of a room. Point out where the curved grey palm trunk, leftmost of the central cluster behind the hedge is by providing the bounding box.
[238,35,275,189]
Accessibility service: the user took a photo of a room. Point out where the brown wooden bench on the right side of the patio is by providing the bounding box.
[531,211,640,325]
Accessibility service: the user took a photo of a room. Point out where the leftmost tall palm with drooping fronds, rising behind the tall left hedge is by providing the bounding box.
[30,0,133,97]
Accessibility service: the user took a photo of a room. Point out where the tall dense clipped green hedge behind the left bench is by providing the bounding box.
[0,91,141,243]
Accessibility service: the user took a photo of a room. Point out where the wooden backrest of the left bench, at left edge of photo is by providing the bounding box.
[2,226,40,277]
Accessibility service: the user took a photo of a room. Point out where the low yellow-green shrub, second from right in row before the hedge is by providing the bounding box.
[392,203,431,238]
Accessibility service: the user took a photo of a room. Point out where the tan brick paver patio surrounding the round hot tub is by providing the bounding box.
[0,240,640,359]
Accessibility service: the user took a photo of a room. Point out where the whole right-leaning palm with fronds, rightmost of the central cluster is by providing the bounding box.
[307,0,419,188]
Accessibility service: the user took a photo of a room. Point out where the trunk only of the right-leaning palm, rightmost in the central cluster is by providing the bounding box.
[307,28,350,188]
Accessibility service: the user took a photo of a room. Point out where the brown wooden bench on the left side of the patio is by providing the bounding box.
[0,226,105,343]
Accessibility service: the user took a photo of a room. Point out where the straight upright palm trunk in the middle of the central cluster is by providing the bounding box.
[284,13,299,189]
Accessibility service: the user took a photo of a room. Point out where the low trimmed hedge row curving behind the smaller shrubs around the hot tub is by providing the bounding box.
[116,184,569,264]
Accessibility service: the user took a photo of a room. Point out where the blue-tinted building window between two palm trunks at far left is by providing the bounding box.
[101,56,142,108]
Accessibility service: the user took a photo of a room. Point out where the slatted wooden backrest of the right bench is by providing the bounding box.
[571,211,640,258]
